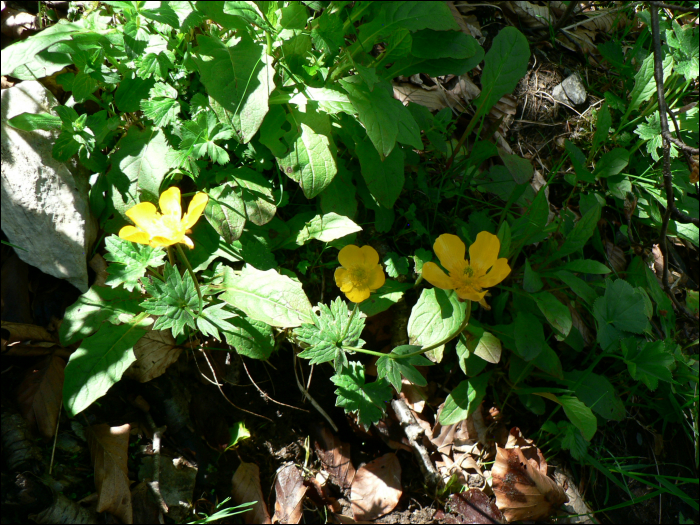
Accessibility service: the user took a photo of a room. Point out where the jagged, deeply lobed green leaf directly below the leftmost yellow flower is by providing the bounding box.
[141,262,199,337]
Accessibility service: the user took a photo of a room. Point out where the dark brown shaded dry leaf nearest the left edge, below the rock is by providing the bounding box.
[17,355,66,438]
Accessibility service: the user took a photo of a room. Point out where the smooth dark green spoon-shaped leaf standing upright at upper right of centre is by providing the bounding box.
[474,27,530,114]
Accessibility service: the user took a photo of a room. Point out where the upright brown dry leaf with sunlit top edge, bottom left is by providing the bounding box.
[86,424,132,523]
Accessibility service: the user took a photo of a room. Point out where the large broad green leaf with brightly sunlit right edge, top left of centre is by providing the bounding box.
[194,33,275,144]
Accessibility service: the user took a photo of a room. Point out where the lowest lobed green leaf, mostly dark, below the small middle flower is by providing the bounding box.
[331,361,392,429]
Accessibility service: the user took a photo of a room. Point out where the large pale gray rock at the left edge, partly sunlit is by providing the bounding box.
[0,81,97,292]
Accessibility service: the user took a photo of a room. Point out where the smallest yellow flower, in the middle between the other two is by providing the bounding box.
[335,244,385,303]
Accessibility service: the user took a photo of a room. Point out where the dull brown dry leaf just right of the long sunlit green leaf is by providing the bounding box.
[124,330,182,383]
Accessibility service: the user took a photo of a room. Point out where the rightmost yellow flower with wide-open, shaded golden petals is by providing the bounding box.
[423,232,510,309]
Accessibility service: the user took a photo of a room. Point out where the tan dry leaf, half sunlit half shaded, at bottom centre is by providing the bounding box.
[350,453,403,520]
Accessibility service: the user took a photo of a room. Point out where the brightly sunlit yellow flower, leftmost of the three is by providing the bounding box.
[119,186,209,248]
